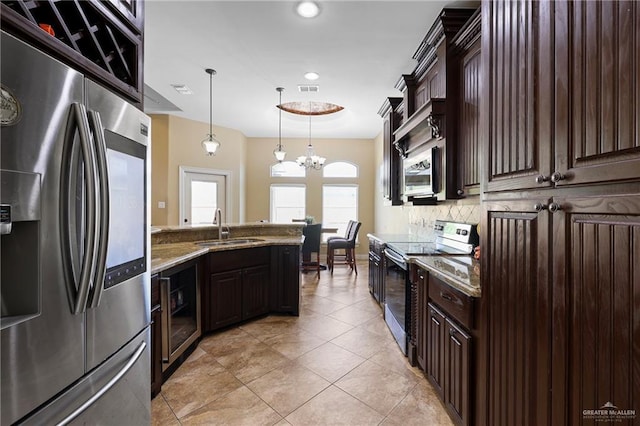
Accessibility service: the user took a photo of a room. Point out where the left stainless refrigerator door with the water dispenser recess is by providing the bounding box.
[0,32,85,424]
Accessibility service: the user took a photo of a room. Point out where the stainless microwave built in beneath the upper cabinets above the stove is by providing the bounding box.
[403,147,440,197]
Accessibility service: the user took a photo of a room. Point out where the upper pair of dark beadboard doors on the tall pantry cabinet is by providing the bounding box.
[482,1,640,192]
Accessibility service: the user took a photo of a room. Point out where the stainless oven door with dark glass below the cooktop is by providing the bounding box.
[384,248,411,355]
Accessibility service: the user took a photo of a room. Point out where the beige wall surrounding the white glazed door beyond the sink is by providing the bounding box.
[151,115,247,226]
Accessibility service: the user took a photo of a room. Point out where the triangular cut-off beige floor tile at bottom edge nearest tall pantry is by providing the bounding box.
[383,381,453,426]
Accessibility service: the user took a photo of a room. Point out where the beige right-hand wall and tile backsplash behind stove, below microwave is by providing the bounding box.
[374,133,480,238]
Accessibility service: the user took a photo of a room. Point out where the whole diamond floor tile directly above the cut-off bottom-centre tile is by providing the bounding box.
[298,343,365,383]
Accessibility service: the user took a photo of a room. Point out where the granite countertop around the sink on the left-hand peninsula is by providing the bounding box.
[151,235,302,275]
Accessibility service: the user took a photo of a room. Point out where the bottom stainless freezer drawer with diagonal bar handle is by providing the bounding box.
[24,328,151,426]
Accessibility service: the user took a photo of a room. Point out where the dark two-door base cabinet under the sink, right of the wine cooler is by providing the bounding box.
[203,247,270,332]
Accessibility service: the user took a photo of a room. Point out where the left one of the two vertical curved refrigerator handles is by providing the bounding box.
[66,103,97,314]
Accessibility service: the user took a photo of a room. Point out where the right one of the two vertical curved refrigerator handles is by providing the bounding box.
[88,111,109,308]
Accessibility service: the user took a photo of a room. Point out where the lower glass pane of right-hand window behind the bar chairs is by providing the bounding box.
[322,185,358,240]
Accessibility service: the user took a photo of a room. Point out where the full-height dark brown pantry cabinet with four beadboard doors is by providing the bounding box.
[476,1,640,425]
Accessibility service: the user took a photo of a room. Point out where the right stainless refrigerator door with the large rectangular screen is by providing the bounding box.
[86,80,151,369]
